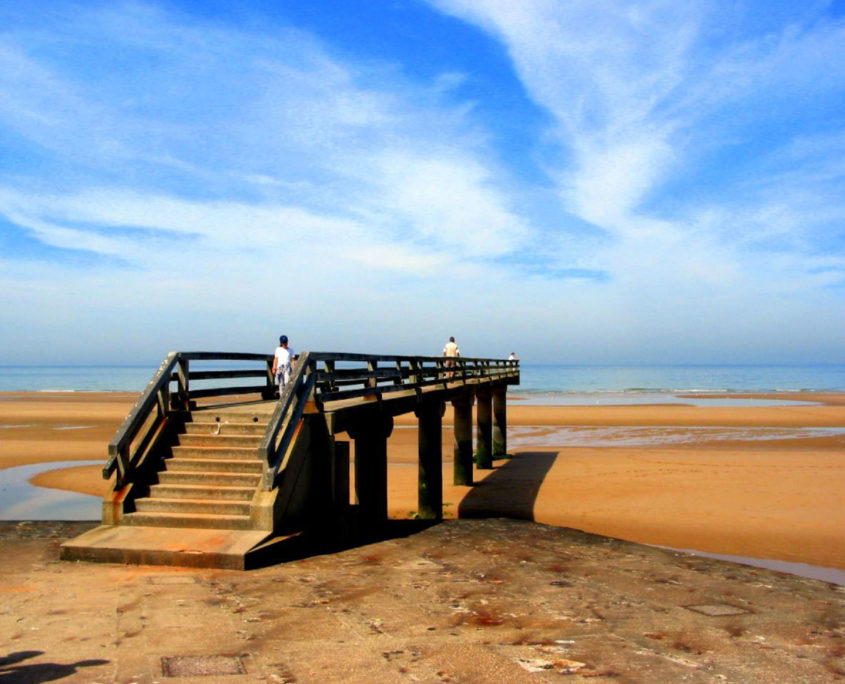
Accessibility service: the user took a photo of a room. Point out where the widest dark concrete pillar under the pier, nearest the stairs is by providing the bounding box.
[349,411,393,525]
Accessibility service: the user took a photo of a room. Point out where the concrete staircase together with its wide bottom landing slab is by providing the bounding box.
[67,402,276,569]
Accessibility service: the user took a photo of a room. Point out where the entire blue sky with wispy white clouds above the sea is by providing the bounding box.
[0,0,845,364]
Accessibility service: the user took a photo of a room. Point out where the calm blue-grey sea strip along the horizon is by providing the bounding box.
[0,363,845,392]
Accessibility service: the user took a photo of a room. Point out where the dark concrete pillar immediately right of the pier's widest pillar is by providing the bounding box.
[414,400,445,520]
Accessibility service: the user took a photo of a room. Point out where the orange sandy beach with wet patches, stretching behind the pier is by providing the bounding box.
[0,392,845,569]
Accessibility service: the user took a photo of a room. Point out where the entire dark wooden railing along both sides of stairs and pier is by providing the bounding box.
[103,352,519,489]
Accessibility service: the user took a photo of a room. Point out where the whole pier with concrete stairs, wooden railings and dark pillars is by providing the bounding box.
[61,352,519,568]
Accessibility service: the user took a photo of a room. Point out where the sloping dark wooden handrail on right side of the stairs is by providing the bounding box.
[258,351,317,491]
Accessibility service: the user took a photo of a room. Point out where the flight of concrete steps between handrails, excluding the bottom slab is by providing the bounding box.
[123,410,267,530]
